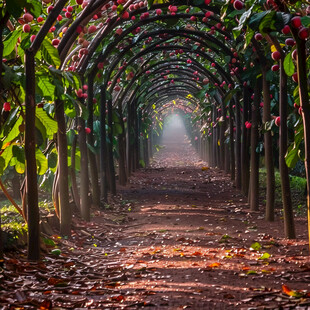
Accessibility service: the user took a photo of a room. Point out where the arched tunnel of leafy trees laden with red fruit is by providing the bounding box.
[0,0,310,260]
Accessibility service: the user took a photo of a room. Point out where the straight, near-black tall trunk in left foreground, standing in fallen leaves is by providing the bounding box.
[25,49,40,261]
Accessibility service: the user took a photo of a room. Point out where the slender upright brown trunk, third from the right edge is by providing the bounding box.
[262,67,275,221]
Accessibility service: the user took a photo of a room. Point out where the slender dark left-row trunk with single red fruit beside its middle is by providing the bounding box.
[87,75,100,207]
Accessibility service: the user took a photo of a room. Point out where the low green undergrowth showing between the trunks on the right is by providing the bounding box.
[259,168,307,215]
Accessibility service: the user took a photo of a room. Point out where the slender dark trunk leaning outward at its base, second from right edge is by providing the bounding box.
[279,58,296,239]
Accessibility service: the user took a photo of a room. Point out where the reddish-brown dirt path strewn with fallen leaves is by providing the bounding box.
[0,129,310,309]
